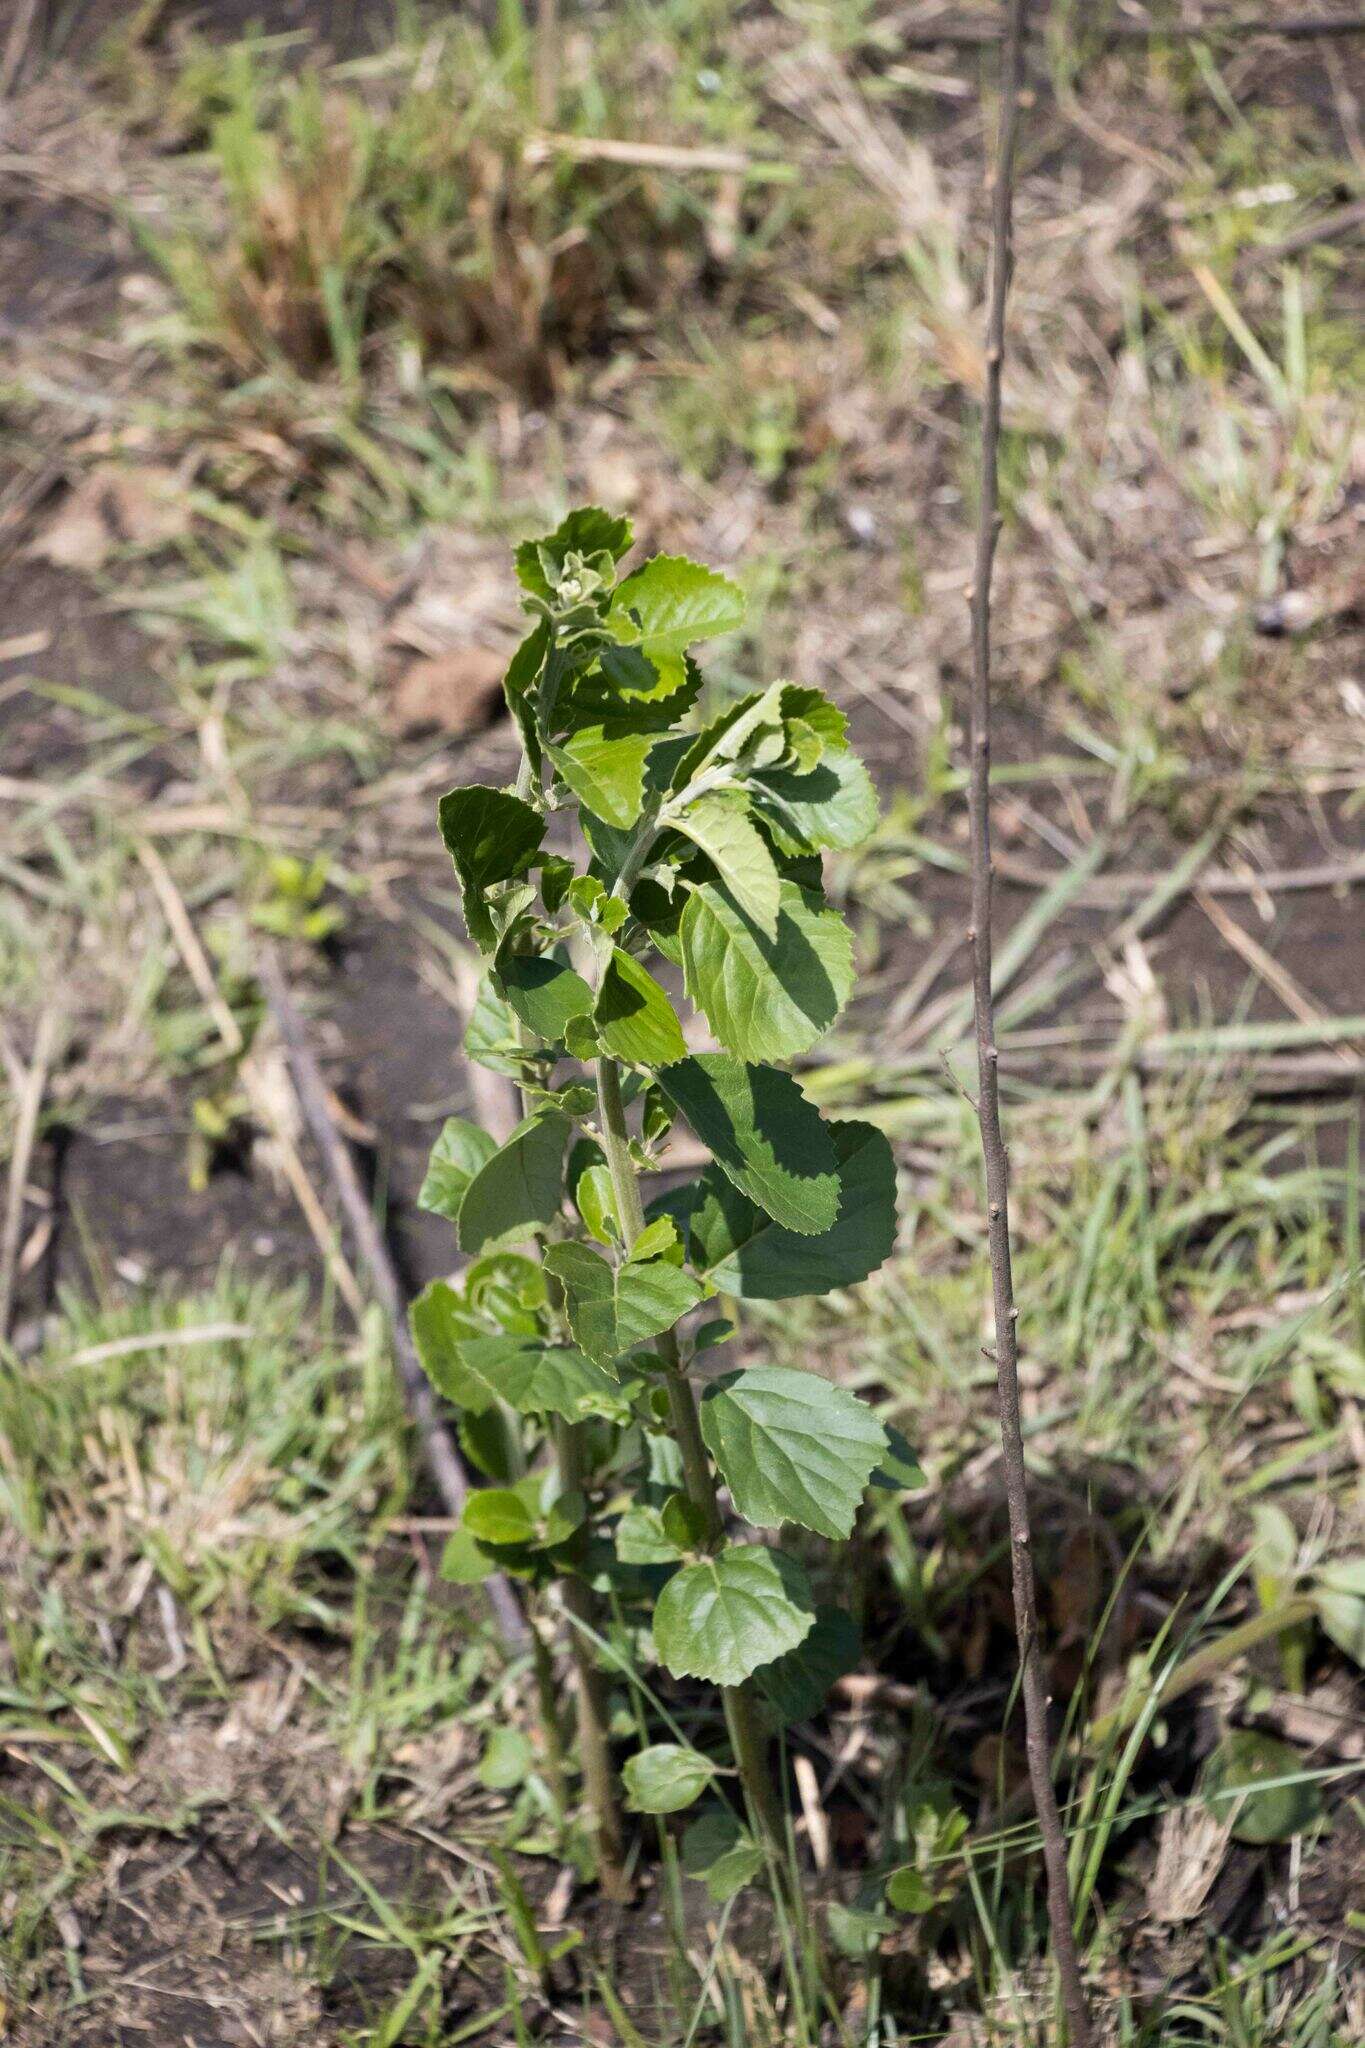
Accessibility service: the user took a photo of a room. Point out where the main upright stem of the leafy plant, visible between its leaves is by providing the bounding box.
[598,1059,786,1862]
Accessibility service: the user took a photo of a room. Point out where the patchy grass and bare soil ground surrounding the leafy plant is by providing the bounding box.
[0,6,1365,2048]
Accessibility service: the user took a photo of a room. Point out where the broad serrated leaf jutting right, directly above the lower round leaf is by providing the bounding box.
[702,1366,886,1538]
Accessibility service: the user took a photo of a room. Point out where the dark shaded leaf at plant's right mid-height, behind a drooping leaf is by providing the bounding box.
[690,1122,896,1300]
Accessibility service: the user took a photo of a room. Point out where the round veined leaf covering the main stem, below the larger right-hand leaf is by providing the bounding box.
[653,1544,814,1686]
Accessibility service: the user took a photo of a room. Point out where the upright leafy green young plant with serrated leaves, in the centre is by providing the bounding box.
[411,506,919,1896]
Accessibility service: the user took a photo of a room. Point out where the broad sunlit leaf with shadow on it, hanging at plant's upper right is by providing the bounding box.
[681,883,853,1059]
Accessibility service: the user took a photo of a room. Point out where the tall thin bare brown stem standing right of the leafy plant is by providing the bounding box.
[968,0,1091,2048]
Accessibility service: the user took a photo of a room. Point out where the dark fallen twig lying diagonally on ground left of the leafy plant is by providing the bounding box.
[256,940,530,1649]
